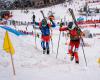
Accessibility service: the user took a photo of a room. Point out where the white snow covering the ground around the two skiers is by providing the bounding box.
[0,1,100,80]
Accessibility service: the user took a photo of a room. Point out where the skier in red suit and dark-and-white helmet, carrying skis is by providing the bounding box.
[59,22,84,64]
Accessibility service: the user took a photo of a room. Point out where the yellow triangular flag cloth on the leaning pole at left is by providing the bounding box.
[3,31,15,55]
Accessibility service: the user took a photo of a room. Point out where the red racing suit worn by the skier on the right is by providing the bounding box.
[59,27,83,61]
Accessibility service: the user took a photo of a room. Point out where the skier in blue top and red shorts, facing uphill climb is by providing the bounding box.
[35,18,55,54]
